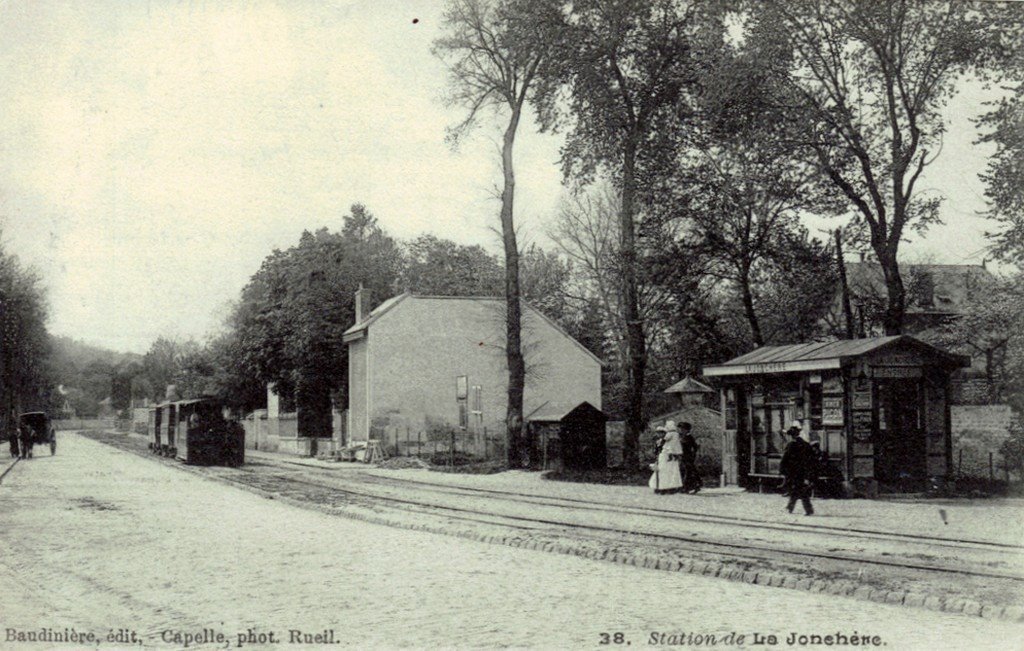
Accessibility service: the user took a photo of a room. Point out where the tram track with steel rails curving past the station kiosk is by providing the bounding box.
[75,436,1024,585]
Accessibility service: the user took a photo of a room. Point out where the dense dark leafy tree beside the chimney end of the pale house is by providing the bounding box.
[225,204,401,436]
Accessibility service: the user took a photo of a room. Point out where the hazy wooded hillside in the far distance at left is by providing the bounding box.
[50,337,142,417]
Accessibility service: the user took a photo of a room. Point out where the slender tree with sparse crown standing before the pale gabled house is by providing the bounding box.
[434,0,548,468]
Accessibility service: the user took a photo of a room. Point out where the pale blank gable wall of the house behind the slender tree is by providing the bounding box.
[349,297,601,440]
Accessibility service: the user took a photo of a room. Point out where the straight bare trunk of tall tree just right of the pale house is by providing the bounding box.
[618,135,647,469]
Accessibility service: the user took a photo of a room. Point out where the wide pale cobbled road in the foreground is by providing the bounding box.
[0,435,1024,649]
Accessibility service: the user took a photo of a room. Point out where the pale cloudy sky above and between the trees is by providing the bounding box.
[0,0,1007,353]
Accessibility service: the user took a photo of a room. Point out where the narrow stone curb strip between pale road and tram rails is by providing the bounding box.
[83,431,1024,622]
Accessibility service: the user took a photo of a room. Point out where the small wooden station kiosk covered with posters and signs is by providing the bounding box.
[705,335,970,495]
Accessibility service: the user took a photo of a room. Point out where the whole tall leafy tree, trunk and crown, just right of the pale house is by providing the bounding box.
[539,0,724,464]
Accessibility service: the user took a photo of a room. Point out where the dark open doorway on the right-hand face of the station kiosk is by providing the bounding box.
[874,378,928,490]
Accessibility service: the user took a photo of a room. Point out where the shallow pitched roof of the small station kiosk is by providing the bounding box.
[703,335,967,376]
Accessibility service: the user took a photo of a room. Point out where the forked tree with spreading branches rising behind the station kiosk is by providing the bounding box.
[746,0,1007,334]
